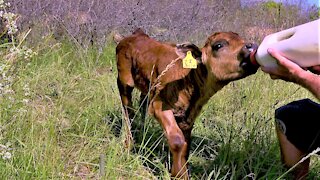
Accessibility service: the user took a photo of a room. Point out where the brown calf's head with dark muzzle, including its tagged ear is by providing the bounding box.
[177,32,258,82]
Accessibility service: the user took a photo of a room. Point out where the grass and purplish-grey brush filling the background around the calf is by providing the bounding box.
[0,0,320,179]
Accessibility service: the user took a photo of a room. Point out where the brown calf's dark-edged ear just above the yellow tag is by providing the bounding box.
[176,42,202,64]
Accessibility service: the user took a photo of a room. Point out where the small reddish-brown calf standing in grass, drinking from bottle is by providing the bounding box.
[116,29,257,179]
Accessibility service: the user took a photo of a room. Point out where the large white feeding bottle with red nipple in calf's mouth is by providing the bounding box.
[250,19,320,68]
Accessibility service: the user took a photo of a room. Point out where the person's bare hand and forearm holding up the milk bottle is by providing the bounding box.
[261,49,320,100]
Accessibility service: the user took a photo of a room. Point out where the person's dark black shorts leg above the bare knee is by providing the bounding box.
[275,99,320,153]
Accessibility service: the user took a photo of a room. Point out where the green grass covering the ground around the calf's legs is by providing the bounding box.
[0,39,320,179]
